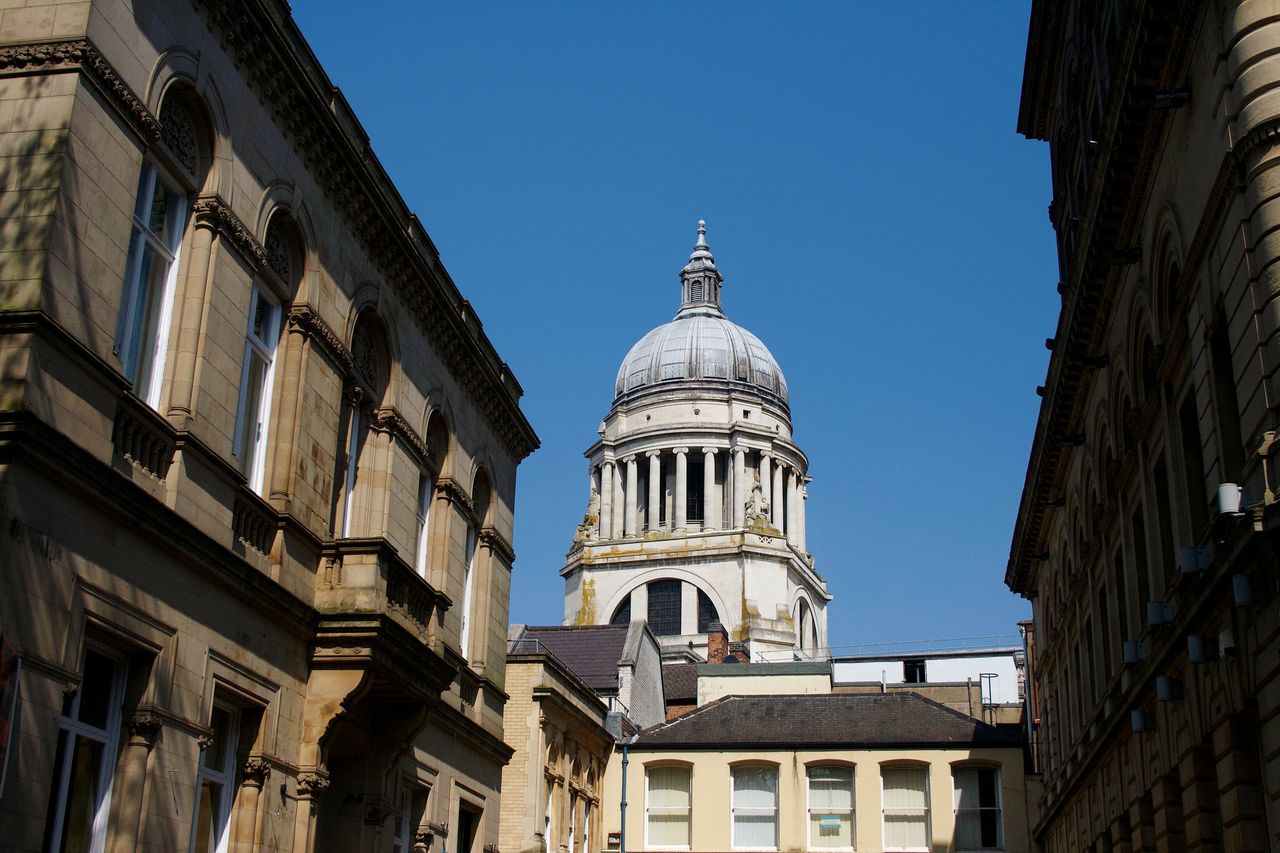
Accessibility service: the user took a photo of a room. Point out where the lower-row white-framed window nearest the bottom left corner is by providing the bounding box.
[46,643,128,853]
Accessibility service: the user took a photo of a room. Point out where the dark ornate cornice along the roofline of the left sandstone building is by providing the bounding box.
[186,0,539,461]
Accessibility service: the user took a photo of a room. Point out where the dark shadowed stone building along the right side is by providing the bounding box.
[1006,0,1280,853]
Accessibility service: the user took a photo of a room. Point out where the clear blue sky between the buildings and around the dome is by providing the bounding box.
[293,0,1057,651]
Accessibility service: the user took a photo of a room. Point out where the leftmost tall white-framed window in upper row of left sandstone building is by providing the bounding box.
[113,158,191,409]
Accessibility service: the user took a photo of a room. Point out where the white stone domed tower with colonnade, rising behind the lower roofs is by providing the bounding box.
[561,222,831,660]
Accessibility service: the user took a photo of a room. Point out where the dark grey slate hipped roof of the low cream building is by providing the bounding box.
[634,693,1021,749]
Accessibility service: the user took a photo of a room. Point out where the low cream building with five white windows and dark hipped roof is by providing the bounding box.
[604,691,1032,853]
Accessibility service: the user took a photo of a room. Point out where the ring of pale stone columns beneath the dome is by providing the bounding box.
[590,447,809,551]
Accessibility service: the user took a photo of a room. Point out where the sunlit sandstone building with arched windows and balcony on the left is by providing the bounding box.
[0,0,538,853]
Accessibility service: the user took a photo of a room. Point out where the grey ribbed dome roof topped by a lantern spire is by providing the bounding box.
[613,222,787,405]
